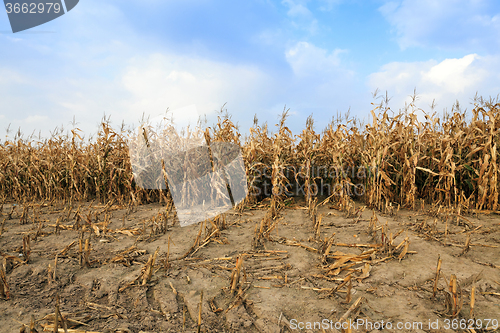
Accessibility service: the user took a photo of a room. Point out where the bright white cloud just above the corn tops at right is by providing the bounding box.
[368,54,500,111]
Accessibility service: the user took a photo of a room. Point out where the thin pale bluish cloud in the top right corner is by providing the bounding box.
[379,0,500,53]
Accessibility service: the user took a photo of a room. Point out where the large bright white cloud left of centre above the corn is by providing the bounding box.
[121,54,272,124]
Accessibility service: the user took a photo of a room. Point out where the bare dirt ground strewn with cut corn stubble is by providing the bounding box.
[0,201,500,333]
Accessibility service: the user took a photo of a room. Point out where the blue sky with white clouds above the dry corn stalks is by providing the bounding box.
[0,0,500,136]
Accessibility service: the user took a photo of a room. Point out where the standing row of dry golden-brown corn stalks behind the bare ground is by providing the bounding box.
[0,100,500,215]
